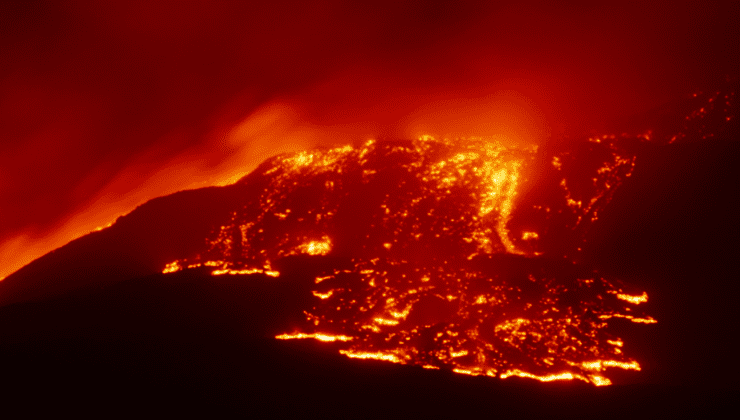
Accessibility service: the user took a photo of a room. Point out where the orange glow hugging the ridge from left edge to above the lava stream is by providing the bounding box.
[0,82,549,279]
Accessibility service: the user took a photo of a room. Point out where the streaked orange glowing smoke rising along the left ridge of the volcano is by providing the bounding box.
[0,103,335,279]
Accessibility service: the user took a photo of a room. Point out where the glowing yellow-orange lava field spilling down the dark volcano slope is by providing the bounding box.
[164,130,656,385]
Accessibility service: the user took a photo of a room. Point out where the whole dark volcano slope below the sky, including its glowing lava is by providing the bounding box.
[0,80,740,417]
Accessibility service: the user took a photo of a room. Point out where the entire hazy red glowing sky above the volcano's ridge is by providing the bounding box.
[0,0,740,278]
